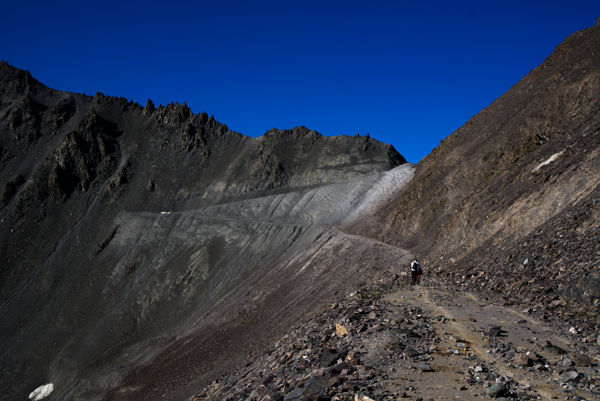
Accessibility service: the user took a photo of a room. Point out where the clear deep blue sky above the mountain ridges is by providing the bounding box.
[0,0,600,162]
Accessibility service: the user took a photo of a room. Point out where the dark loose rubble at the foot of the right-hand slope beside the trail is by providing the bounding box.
[432,181,600,334]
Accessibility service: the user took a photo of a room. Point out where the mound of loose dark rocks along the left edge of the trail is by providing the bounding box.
[195,284,435,400]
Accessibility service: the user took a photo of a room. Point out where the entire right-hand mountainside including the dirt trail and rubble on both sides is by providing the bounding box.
[190,21,600,401]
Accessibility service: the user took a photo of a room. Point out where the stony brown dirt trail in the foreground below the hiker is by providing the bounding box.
[385,285,594,400]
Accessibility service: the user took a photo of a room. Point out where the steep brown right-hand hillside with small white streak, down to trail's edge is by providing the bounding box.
[353,24,600,318]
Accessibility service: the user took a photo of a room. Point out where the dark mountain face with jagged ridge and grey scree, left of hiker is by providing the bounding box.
[0,63,413,400]
